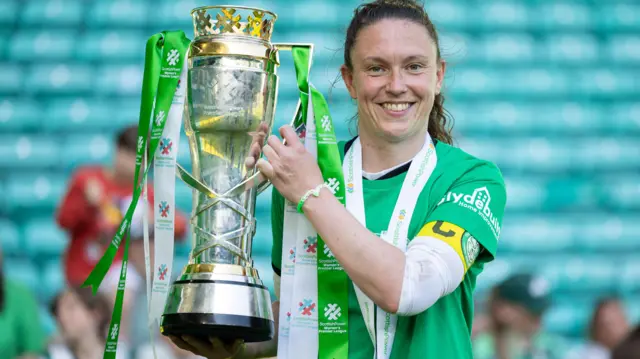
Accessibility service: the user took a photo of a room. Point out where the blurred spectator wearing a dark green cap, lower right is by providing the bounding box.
[473,274,566,359]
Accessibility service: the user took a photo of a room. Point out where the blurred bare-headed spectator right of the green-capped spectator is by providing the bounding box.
[569,298,630,359]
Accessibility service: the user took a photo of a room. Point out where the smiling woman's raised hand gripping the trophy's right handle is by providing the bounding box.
[257,125,324,203]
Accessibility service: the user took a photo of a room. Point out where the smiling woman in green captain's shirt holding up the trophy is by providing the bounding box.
[169,0,506,359]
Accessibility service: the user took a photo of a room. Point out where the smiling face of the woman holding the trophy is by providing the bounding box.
[342,19,445,142]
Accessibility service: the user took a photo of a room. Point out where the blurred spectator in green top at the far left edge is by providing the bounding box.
[0,252,45,359]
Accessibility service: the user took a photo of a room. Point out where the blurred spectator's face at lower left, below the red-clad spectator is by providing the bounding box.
[57,292,97,341]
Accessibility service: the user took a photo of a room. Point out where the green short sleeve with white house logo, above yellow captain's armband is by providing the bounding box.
[427,163,507,259]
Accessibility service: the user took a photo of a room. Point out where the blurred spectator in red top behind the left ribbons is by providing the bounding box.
[57,126,186,342]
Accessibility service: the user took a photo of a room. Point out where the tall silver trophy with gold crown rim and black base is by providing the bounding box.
[160,6,279,342]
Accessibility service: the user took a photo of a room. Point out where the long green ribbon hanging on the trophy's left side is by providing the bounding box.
[83,31,191,359]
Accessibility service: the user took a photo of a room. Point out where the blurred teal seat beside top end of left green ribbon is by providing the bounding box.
[76,30,147,64]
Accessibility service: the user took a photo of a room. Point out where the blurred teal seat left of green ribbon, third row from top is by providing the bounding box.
[95,65,144,96]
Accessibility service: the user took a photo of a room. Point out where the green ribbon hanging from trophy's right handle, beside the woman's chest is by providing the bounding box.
[292,46,349,359]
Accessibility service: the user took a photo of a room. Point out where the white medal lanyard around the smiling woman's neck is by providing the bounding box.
[343,134,437,359]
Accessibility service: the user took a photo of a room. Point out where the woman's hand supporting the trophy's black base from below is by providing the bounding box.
[169,335,244,359]
